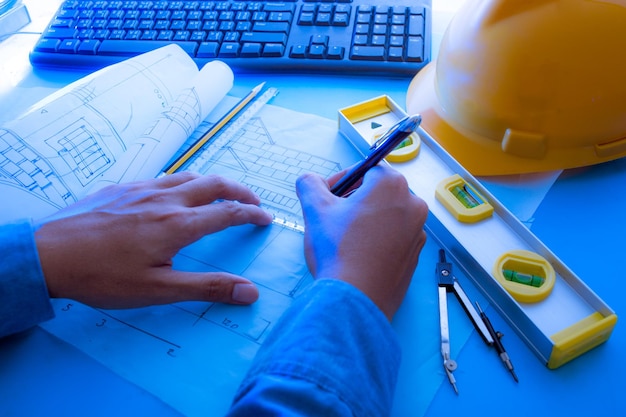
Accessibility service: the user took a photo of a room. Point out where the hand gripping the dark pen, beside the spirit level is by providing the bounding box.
[297,166,428,320]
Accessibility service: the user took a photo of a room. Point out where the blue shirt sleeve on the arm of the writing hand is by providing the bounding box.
[229,279,400,417]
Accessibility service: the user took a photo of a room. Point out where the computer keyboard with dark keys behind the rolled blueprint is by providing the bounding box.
[30,0,432,76]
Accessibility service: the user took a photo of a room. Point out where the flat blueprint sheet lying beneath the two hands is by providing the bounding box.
[42,101,360,416]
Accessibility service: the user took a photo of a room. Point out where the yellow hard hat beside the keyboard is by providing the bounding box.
[406,0,626,175]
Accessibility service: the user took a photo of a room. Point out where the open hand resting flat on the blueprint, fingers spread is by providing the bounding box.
[35,172,272,308]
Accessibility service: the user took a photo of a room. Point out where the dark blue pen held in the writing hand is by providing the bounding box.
[330,114,422,197]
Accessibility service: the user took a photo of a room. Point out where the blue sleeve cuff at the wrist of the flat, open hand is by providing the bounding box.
[0,220,54,337]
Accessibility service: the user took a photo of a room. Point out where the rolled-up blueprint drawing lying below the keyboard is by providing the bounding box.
[0,45,233,221]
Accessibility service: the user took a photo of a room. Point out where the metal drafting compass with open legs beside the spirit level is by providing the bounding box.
[435,249,518,394]
